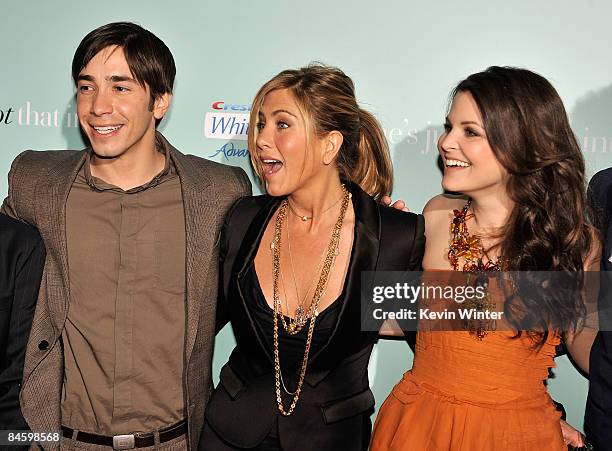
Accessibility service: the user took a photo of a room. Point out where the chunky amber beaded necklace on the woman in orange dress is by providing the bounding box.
[448,199,503,340]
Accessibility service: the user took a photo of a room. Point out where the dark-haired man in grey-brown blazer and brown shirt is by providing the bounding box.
[2,23,251,450]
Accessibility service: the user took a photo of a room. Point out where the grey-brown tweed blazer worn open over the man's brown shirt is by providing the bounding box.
[2,133,251,450]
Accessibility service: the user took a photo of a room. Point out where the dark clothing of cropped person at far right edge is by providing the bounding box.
[584,168,612,450]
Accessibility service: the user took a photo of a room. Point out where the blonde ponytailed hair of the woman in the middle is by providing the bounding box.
[248,63,393,198]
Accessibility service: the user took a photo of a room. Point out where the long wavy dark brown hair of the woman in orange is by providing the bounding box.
[451,66,595,346]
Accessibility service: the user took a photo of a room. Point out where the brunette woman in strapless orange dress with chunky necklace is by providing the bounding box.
[371,67,599,451]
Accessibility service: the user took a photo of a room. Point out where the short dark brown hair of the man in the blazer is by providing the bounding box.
[72,22,176,108]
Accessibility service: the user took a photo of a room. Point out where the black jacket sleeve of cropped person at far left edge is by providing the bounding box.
[0,214,45,430]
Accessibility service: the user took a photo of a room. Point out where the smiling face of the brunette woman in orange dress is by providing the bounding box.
[438,92,508,197]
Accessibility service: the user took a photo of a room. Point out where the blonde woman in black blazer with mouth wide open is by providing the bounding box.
[200,65,424,451]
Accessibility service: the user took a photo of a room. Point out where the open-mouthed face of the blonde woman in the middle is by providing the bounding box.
[255,89,325,196]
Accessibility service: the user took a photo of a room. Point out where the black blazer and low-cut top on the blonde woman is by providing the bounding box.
[200,184,425,451]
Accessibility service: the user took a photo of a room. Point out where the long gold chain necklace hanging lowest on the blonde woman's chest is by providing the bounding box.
[272,187,351,416]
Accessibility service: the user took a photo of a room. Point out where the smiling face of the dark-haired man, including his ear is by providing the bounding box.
[77,46,171,158]
